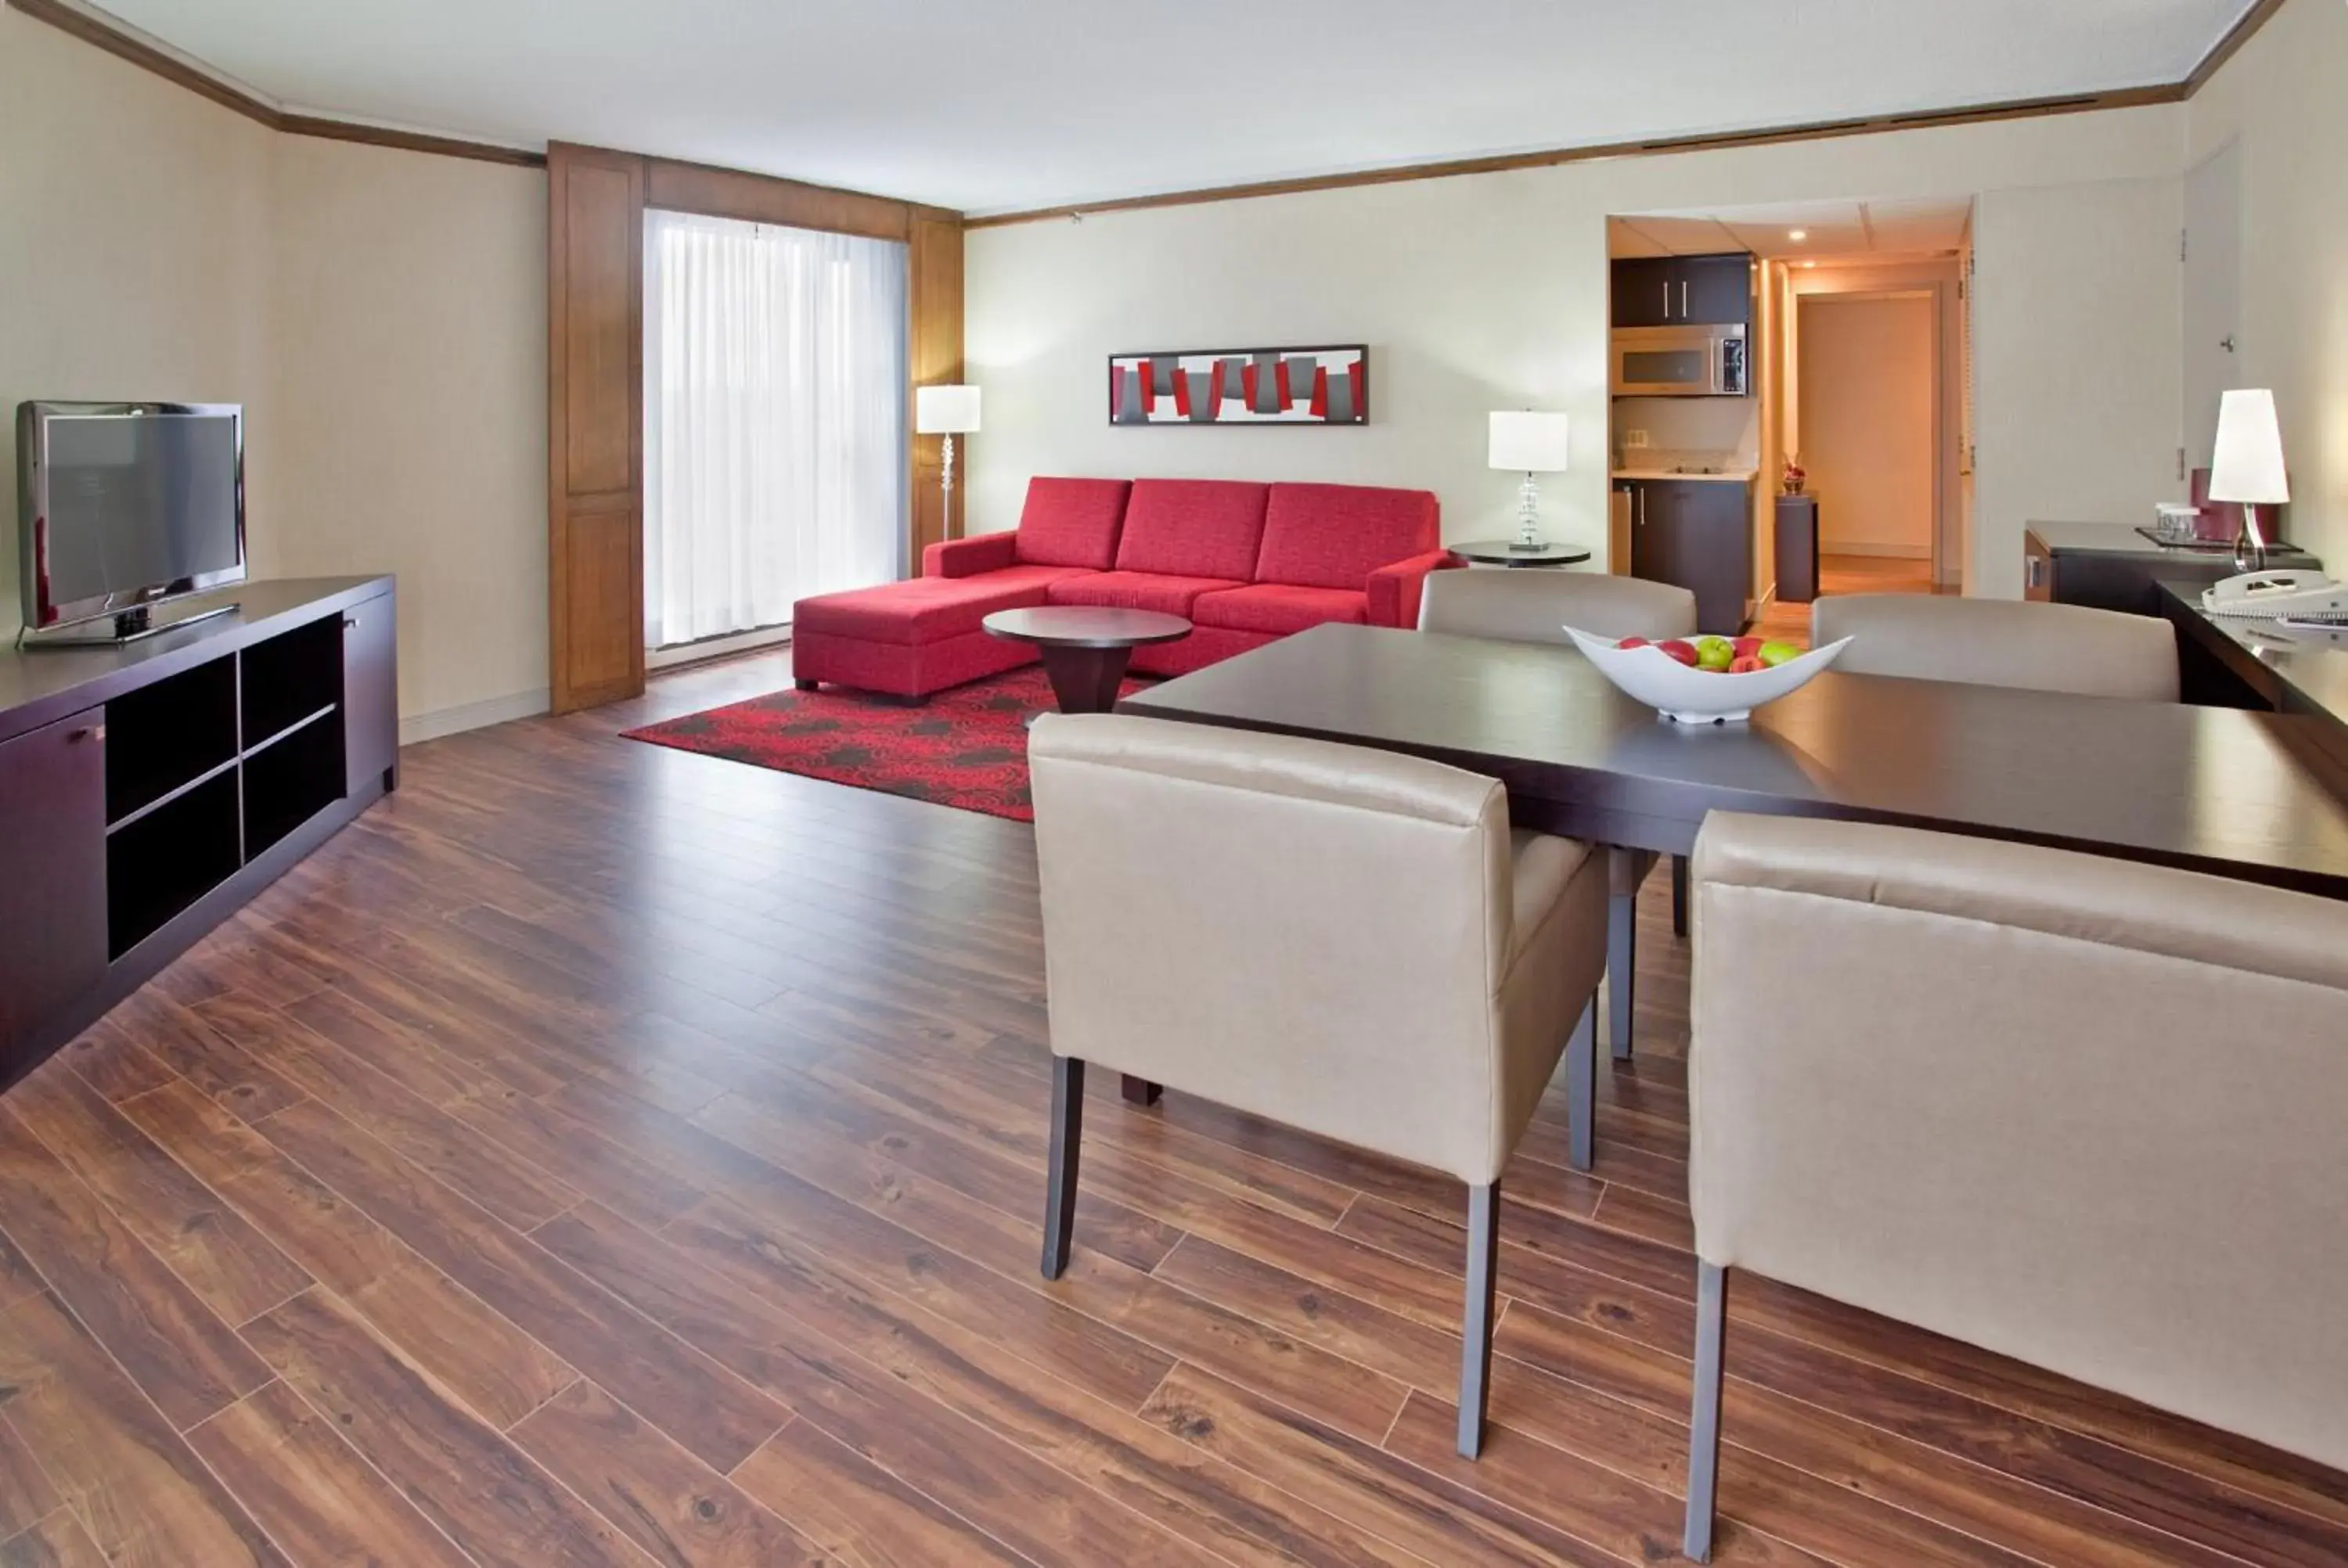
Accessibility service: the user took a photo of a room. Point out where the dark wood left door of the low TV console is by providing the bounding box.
[0,707,106,1084]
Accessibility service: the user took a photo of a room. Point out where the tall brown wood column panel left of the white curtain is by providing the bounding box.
[547,143,646,714]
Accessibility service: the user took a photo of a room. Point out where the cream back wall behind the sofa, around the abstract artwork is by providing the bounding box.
[967,106,2184,596]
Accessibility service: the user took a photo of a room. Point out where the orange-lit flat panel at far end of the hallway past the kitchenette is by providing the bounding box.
[1799,293,1937,561]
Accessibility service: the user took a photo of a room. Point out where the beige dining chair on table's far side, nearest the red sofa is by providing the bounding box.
[1418,566,1695,1061]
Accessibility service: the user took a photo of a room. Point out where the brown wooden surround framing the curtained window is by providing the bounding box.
[547,141,963,714]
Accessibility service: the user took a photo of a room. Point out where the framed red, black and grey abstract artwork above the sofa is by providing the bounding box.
[1108,343,1369,425]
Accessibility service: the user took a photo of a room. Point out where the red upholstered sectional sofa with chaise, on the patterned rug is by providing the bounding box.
[791,479,1458,697]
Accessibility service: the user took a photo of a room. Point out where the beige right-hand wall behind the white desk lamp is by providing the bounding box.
[2186,0,2348,575]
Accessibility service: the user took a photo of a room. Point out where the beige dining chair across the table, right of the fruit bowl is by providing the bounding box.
[1810,594,2177,702]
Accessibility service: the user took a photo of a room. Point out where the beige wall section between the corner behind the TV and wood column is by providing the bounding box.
[270,136,547,739]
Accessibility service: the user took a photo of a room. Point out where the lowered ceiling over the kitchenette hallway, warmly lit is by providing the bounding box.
[1606,197,1972,263]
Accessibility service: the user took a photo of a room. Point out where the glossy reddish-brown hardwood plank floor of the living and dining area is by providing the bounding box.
[0,655,2348,1568]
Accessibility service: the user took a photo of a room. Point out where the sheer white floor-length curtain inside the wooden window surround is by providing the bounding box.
[643,211,906,648]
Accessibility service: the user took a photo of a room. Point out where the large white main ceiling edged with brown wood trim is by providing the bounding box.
[106,0,2252,214]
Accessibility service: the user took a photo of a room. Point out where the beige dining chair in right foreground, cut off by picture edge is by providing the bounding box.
[1684,812,2348,1561]
